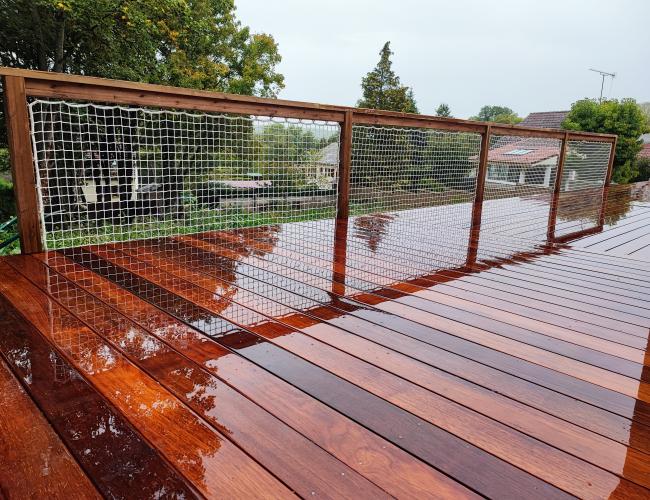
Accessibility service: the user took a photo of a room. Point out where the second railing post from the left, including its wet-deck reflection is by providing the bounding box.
[332,110,354,295]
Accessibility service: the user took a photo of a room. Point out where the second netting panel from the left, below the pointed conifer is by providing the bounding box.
[348,125,481,274]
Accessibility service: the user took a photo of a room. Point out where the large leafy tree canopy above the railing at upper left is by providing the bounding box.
[0,0,283,97]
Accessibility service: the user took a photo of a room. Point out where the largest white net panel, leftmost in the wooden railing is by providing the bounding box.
[29,100,340,249]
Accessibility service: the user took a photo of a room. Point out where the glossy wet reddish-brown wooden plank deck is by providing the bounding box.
[0,188,650,498]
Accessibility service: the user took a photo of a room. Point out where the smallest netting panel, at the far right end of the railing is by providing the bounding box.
[555,141,611,236]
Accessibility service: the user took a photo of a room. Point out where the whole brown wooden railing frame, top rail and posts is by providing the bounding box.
[0,68,616,256]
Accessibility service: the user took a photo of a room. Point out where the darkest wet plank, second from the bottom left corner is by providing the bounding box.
[0,296,196,498]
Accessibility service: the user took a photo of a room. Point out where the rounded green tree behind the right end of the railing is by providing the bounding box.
[562,99,648,183]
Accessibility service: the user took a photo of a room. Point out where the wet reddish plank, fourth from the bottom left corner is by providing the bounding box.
[9,258,394,498]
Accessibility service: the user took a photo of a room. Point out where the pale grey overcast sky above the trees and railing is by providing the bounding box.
[236,0,650,118]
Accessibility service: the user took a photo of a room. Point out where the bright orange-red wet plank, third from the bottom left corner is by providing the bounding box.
[0,262,291,498]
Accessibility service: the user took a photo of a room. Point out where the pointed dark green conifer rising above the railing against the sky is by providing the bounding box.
[357,42,418,113]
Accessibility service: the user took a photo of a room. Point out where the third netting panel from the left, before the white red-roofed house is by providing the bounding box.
[475,135,561,258]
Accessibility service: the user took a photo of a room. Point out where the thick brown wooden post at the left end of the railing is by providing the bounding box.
[3,76,43,253]
